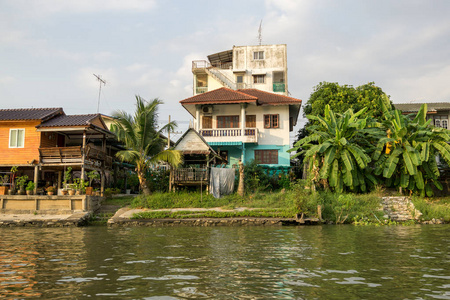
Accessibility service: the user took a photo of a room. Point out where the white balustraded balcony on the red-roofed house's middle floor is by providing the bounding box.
[200,128,258,143]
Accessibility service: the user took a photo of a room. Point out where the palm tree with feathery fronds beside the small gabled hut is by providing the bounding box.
[111,95,182,195]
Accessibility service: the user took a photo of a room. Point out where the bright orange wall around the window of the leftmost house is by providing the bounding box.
[0,121,41,165]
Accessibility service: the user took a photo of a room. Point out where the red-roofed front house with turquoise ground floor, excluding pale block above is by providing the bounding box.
[180,87,302,167]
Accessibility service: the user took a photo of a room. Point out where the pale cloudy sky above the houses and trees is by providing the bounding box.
[0,0,450,142]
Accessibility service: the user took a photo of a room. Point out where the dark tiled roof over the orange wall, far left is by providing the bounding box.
[0,107,64,121]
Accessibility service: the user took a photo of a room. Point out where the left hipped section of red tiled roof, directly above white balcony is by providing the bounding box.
[180,87,258,104]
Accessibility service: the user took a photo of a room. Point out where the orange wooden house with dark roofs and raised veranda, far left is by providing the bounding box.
[0,108,117,192]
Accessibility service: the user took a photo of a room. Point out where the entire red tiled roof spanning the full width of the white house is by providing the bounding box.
[180,87,302,105]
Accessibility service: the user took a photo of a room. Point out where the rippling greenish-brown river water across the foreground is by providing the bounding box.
[0,225,450,299]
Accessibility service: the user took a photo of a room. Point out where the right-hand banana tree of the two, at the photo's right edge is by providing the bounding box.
[373,99,450,196]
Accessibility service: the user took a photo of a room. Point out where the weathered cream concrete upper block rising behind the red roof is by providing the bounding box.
[192,45,288,96]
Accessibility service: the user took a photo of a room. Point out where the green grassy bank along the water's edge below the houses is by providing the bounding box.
[130,184,450,225]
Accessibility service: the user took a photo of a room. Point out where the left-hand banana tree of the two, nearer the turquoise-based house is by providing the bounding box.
[289,105,377,192]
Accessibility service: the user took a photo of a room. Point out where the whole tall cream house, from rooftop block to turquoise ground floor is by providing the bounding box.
[180,45,302,167]
